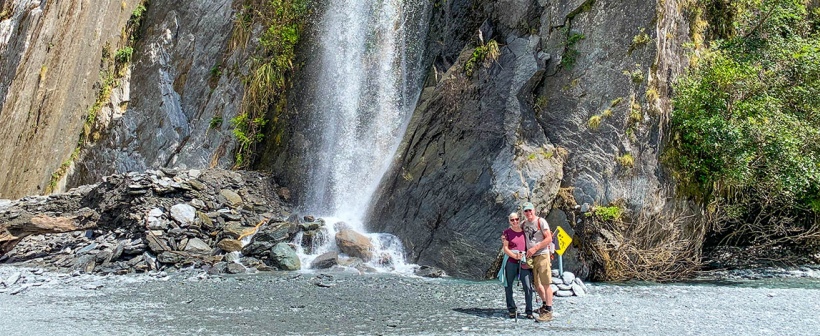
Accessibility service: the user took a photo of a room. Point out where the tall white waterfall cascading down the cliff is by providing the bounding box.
[304,0,429,272]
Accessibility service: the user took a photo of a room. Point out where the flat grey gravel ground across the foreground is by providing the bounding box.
[0,266,820,335]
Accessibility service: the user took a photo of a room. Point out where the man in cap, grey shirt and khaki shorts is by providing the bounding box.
[522,202,552,322]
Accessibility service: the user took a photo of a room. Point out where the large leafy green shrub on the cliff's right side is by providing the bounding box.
[665,0,820,252]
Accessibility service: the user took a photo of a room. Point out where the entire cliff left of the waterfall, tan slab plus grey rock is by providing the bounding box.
[0,0,247,197]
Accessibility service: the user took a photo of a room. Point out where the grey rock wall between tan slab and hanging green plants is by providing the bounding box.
[68,0,247,186]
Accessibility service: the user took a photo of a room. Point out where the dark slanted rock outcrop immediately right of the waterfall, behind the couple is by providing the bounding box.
[370,36,564,278]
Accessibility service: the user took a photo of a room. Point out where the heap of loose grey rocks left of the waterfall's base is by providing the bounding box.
[0,169,334,274]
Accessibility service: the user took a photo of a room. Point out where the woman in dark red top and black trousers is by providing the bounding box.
[501,212,533,319]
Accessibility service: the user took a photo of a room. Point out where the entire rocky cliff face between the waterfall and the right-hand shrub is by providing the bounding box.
[370,0,692,277]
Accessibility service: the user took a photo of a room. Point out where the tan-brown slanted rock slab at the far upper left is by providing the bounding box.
[0,0,139,198]
